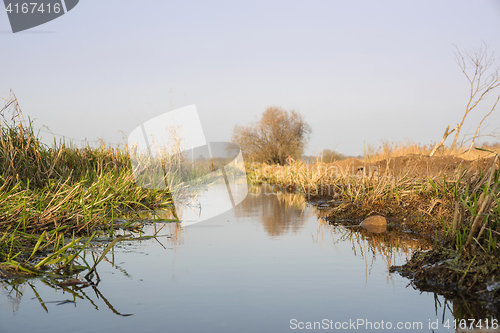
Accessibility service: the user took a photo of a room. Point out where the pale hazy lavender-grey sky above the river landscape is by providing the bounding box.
[0,0,500,154]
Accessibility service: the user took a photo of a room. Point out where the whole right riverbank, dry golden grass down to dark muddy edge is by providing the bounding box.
[249,152,500,302]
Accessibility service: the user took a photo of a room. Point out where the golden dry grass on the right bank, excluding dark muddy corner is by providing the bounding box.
[250,148,500,250]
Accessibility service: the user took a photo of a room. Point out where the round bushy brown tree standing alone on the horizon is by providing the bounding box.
[231,106,311,165]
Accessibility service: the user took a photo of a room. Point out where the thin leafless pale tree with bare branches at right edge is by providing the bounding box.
[451,42,500,151]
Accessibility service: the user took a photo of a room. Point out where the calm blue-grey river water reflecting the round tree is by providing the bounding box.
[0,183,466,333]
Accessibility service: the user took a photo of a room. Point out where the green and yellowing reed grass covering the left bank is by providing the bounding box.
[0,96,173,274]
